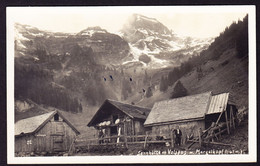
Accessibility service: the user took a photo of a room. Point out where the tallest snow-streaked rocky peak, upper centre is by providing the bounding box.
[120,14,213,68]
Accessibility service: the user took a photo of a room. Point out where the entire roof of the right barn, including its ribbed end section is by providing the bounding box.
[144,92,229,126]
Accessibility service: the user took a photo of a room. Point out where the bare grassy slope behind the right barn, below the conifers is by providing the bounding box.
[128,49,248,108]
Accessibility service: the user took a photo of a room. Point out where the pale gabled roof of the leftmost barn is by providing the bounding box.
[15,111,80,136]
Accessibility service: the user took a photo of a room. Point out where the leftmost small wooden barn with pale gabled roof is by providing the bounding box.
[15,111,80,153]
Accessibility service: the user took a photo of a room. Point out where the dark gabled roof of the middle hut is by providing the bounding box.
[88,99,151,126]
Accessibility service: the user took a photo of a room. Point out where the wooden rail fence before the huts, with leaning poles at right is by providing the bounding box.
[75,109,239,150]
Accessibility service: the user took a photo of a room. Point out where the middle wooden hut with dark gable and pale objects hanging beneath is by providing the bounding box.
[87,99,150,140]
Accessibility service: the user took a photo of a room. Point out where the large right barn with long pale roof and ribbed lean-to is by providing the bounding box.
[144,92,237,143]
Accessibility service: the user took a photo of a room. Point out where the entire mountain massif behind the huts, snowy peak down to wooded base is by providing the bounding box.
[15,14,217,115]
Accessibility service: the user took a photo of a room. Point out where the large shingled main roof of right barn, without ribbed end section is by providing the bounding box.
[144,92,211,125]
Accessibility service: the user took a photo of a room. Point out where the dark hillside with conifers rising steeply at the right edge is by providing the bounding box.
[133,16,250,109]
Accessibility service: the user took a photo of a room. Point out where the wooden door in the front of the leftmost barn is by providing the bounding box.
[53,122,64,152]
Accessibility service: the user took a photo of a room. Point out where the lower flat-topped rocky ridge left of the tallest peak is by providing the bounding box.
[15,24,129,65]
